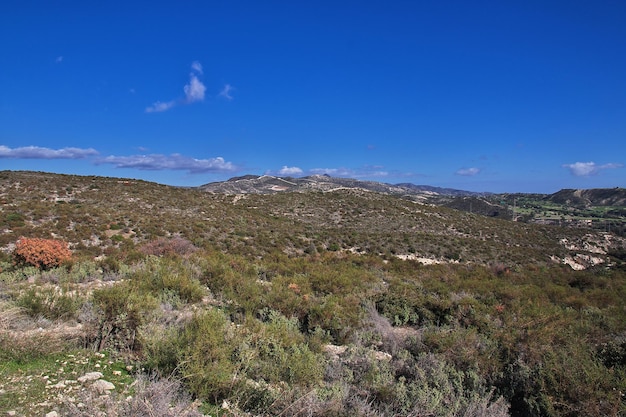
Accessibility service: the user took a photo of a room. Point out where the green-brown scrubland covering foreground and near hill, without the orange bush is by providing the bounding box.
[0,172,626,417]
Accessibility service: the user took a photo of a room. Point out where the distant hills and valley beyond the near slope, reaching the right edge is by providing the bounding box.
[199,175,626,237]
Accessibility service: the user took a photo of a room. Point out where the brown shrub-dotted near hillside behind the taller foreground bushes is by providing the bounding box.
[0,172,621,268]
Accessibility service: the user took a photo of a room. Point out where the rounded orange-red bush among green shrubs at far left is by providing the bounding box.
[13,237,72,270]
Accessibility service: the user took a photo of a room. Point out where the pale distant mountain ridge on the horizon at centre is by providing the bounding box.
[198,175,483,199]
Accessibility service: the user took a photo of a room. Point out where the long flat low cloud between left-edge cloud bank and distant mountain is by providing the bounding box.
[97,154,237,174]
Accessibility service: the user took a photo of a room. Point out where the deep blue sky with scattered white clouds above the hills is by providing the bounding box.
[0,0,626,193]
